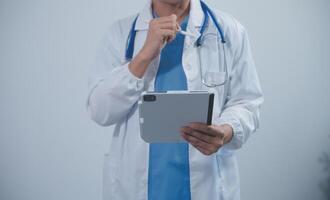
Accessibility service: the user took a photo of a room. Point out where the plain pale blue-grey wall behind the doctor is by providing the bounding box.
[0,0,330,200]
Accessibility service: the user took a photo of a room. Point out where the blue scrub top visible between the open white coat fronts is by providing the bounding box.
[148,12,191,200]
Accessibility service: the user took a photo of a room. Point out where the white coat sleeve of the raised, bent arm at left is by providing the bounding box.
[86,23,144,126]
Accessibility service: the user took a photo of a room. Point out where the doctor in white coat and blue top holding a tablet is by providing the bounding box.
[86,0,263,200]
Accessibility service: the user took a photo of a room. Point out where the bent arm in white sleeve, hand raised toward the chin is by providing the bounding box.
[86,15,176,126]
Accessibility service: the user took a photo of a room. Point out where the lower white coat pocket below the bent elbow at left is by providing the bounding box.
[103,153,115,200]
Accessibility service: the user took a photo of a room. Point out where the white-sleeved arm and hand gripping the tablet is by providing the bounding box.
[180,20,263,155]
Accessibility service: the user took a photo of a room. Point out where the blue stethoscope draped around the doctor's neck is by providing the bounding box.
[125,1,228,88]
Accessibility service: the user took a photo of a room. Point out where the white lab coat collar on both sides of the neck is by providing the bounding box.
[135,0,204,43]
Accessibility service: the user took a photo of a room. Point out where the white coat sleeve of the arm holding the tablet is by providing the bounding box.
[218,22,264,150]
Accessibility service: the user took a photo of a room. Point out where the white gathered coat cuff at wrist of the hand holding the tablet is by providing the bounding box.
[217,117,243,152]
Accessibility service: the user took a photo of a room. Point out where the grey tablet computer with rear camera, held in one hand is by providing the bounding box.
[138,90,214,143]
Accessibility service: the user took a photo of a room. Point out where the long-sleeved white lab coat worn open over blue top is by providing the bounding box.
[86,0,263,200]
